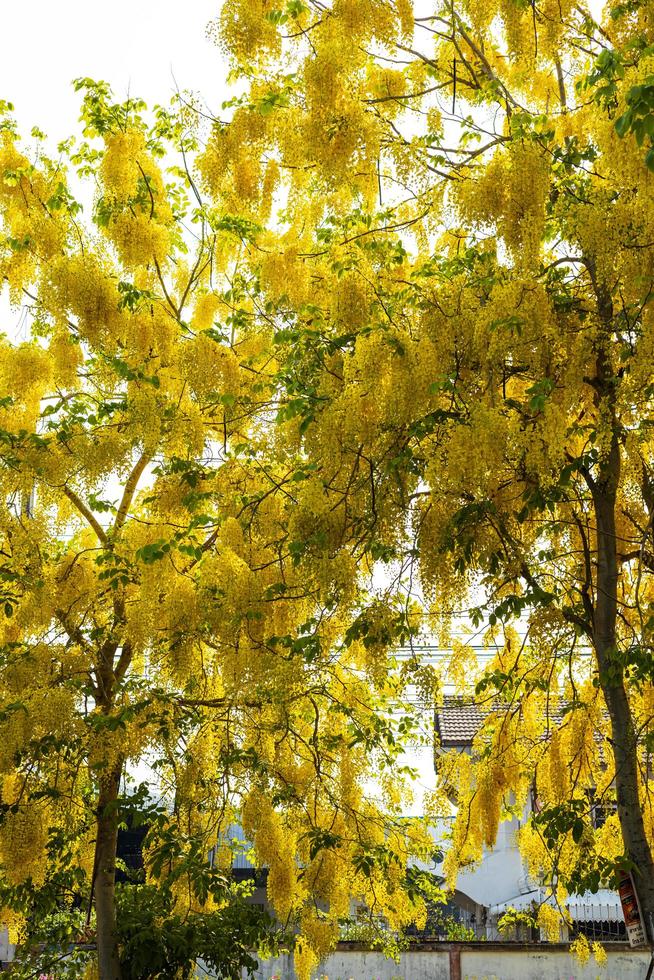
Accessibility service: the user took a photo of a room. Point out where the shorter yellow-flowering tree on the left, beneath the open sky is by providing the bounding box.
[0,79,436,980]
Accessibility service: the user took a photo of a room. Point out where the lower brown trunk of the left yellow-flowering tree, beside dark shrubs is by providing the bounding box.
[94,764,122,980]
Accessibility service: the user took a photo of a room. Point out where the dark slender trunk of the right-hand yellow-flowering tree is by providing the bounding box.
[591,448,654,941]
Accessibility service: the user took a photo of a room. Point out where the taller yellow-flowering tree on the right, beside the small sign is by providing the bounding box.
[208,0,654,939]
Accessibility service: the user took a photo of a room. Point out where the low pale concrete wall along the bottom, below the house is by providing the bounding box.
[238,943,650,980]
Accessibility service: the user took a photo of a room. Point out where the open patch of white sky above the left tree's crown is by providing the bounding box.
[0,0,227,146]
